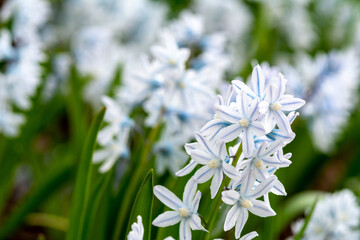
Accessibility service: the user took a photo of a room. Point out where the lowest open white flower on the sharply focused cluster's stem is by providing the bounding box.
[222,176,276,238]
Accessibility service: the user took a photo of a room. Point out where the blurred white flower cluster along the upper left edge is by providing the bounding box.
[0,0,49,136]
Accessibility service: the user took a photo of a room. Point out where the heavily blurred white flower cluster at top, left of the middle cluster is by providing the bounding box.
[47,0,167,108]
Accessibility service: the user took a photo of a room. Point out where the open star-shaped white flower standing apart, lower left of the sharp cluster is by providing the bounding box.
[152,179,206,240]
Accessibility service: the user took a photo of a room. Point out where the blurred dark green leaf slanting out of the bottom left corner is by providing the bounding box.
[0,163,72,239]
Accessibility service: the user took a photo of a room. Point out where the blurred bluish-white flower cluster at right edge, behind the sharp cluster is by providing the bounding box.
[283,49,359,152]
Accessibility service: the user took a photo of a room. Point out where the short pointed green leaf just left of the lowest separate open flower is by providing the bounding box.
[124,169,154,240]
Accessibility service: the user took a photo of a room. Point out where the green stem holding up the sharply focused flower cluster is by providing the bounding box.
[204,143,242,240]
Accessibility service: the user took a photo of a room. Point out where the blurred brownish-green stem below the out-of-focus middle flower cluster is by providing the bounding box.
[113,110,165,240]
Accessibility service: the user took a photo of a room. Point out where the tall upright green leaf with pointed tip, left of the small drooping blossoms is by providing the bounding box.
[66,108,105,240]
